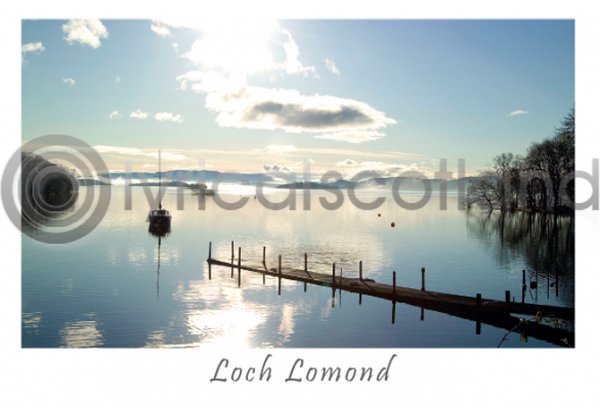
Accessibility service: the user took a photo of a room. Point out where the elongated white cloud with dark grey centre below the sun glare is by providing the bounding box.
[206,87,396,142]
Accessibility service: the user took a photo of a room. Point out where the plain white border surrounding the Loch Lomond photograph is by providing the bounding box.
[0,0,600,406]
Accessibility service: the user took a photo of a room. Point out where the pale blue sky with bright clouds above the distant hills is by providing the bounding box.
[21,18,575,177]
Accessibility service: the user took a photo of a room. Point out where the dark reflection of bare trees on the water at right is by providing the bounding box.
[467,212,575,306]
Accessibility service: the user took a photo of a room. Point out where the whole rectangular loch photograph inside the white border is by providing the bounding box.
[19,16,576,349]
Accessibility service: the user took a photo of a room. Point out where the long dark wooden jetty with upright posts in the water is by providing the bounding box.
[207,241,575,347]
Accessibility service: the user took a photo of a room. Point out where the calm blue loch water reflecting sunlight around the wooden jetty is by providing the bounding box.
[22,187,574,348]
